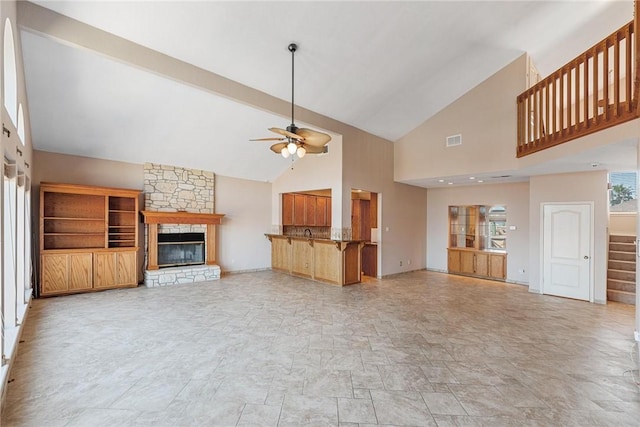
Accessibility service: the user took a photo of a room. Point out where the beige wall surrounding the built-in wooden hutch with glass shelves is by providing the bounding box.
[427,182,529,284]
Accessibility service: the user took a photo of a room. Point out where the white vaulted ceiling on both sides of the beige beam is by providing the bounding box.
[21,1,633,185]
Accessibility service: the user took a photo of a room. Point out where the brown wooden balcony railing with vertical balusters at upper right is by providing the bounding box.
[517,21,638,157]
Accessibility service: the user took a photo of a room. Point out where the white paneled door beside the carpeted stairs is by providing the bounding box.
[542,204,593,301]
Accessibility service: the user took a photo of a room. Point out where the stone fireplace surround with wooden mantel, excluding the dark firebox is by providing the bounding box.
[142,163,224,287]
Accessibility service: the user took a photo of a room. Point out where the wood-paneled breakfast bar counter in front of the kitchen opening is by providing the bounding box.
[266,234,364,286]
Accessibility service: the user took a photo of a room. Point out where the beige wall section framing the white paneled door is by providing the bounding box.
[529,171,609,304]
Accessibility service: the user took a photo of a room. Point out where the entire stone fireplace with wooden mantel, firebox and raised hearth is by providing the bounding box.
[142,163,224,287]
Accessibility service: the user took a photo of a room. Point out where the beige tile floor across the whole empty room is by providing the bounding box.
[2,271,640,427]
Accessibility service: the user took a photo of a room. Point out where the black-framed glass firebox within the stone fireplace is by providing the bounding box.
[158,233,205,268]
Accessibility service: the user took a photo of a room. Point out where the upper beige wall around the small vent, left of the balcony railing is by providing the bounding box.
[394,55,528,182]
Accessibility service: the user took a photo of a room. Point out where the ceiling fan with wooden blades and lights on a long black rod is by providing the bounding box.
[251,43,331,159]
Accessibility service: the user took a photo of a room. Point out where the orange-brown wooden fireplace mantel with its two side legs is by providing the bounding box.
[140,211,224,270]
